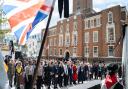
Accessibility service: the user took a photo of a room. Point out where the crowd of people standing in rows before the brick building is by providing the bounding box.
[6,59,121,89]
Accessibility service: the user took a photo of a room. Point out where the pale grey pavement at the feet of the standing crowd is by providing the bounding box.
[11,80,101,89]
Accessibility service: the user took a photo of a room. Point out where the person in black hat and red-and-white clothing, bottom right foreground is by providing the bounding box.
[101,63,123,89]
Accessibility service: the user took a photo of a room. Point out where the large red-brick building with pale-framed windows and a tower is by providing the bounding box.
[44,0,127,61]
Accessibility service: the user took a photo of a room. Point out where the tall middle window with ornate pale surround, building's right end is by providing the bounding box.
[107,27,115,42]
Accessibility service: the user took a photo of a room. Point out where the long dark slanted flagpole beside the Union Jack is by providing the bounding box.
[30,0,56,89]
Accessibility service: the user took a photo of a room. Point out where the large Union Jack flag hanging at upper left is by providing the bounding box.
[2,0,53,45]
